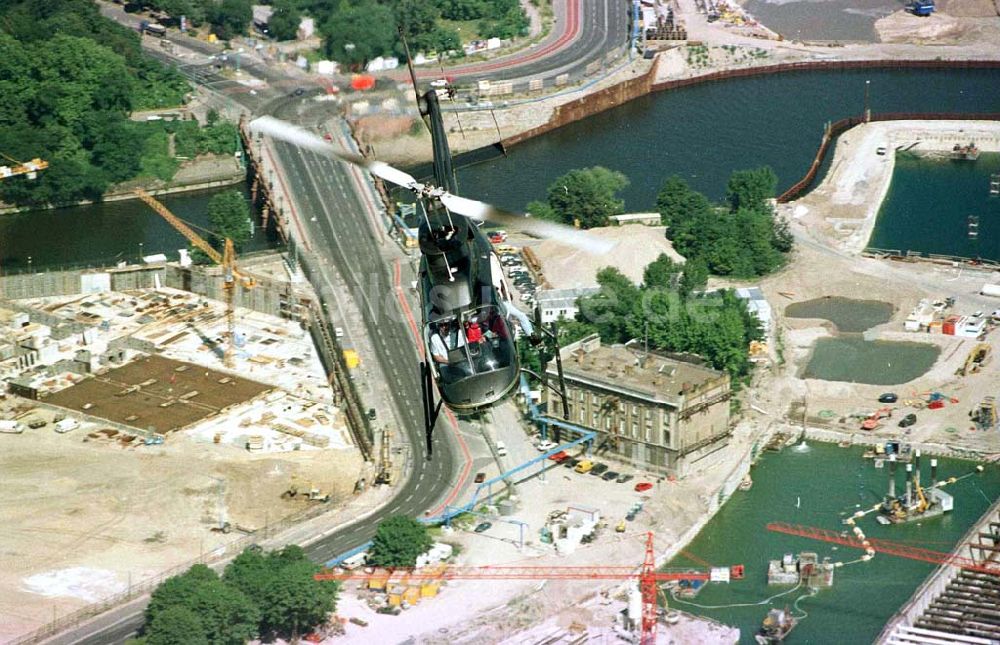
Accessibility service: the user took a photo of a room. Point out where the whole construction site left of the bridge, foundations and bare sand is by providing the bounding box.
[0,258,371,637]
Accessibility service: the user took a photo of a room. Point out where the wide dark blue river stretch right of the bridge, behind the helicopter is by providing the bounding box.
[453,70,1000,212]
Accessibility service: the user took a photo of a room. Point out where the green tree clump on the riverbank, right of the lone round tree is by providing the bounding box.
[656,167,792,278]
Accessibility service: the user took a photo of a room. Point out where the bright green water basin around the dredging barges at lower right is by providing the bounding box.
[668,442,1000,643]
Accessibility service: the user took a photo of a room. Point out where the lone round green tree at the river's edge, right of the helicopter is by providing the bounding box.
[548,166,628,228]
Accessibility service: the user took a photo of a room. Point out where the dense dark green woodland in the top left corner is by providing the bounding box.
[0,0,188,205]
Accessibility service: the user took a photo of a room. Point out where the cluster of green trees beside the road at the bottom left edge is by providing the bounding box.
[140,546,338,645]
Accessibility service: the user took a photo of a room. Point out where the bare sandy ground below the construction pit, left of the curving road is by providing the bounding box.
[0,400,362,641]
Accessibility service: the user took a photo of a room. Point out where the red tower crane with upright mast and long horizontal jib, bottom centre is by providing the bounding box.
[315,533,743,645]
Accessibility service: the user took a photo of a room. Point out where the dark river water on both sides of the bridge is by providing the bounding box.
[7,70,1000,270]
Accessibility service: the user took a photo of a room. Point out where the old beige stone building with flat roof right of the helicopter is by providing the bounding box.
[543,334,732,477]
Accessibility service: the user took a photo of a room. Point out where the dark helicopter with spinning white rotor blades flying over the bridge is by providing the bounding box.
[250,66,610,459]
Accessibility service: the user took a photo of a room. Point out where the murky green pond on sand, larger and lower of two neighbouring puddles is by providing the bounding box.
[802,334,941,385]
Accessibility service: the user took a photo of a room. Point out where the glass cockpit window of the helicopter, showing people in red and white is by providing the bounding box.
[427,305,514,379]
